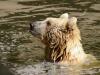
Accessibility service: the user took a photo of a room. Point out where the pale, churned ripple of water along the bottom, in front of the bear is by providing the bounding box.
[12,62,100,75]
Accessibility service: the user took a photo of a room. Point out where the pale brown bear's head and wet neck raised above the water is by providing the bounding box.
[30,13,95,64]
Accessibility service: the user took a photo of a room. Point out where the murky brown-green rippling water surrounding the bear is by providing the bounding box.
[0,0,100,75]
